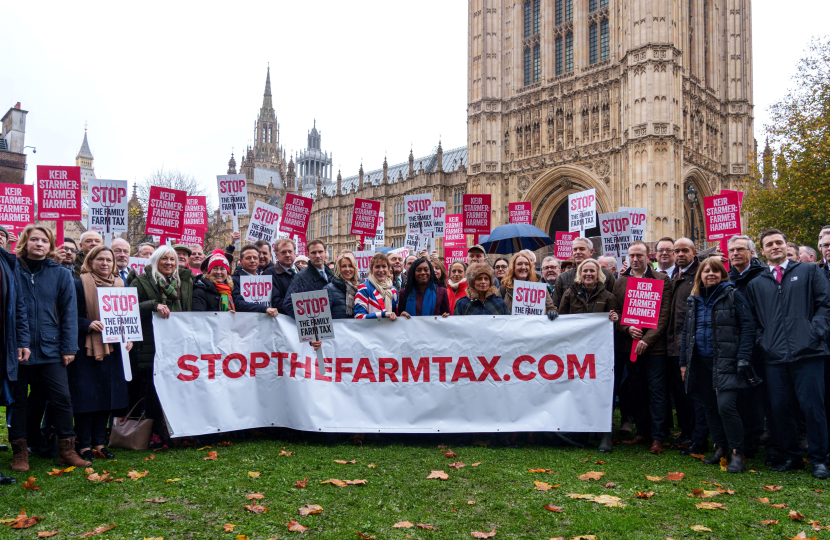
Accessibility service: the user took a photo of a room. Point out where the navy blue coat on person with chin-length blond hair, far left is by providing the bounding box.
[15,259,78,366]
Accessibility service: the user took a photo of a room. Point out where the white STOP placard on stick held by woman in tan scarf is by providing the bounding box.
[96,287,144,381]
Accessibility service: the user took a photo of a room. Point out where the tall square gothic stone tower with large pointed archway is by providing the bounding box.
[467,0,754,240]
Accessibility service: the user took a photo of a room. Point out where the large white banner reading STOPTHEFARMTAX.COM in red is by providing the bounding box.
[153,312,614,437]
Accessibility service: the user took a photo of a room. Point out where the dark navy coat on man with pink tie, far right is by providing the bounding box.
[746,261,830,364]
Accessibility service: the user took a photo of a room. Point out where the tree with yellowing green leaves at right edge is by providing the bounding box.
[743,37,830,247]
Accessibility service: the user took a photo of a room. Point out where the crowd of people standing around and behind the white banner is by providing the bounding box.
[0,220,830,484]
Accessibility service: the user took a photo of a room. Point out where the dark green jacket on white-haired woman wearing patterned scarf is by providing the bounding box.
[130,266,193,370]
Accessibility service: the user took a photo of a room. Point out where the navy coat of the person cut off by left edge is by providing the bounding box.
[0,249,29,382]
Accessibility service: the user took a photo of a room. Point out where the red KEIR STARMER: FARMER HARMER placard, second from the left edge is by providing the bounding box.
[37,165,83,221]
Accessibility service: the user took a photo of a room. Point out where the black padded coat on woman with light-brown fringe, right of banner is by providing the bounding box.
[680,282,755,392]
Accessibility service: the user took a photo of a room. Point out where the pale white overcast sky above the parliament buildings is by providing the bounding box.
[0,0,830,205]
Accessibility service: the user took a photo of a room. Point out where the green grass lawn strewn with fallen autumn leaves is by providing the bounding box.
[0,435,830,540]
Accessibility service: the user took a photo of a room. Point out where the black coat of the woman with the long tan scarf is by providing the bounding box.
[66,279,128,414]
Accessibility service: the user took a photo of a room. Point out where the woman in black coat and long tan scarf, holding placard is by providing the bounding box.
[66,246,133,461]
